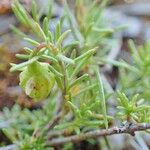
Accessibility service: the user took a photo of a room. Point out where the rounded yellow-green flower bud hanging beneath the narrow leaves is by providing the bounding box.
[19,61,55,100]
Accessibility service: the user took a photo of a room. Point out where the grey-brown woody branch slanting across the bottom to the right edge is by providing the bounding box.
[46,123,150,146]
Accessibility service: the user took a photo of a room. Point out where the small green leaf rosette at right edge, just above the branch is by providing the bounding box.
[117,92,150,122]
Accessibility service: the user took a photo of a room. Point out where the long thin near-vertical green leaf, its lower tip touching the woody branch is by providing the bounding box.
[96,67,108,129]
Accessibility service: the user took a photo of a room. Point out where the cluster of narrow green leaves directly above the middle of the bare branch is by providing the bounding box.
[55,100,113,134]
